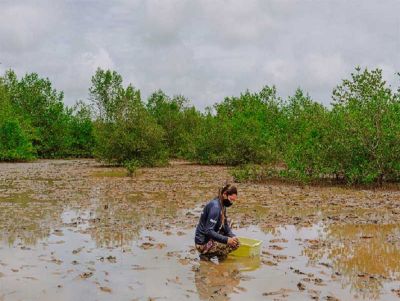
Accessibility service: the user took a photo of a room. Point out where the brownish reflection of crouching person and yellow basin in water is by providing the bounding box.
[194,257,260,300]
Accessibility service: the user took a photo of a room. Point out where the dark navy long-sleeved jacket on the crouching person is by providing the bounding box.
[194,198,235,245]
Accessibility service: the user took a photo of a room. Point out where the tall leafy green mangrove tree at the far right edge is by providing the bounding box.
[330,68,400,183]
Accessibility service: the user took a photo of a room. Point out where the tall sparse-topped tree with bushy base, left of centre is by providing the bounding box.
[90,69,167,166]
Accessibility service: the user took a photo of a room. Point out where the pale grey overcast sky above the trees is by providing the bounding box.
[0,0,400,109]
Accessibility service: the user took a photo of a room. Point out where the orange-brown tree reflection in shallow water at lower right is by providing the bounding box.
[304,224,400,299]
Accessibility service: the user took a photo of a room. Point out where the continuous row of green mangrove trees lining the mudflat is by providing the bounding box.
[0,67,400,184]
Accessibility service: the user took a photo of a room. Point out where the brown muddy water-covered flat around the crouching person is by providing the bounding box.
[0,160,400,301]
